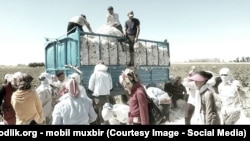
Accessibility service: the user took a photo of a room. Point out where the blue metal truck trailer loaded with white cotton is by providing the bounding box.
[45,29,170,96]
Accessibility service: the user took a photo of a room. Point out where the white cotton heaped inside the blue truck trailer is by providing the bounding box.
[81,24,170,65]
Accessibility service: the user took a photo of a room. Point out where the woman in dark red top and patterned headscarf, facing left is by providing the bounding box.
[119,68,149,125]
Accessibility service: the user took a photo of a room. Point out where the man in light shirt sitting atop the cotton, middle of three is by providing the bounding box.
[106,6,123,34]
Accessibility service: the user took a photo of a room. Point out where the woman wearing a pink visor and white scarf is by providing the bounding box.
[188,71,220,125]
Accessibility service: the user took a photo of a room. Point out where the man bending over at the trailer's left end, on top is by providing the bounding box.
[67,14,93,35]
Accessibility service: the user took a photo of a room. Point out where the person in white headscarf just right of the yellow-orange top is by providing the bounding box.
[36,73,53,124]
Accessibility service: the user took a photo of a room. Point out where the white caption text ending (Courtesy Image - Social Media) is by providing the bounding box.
[0,128,247,138]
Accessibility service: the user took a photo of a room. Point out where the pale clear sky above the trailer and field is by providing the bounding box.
[0,0,250,65]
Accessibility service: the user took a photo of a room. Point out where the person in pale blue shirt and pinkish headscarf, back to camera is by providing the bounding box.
[52,78,97,125]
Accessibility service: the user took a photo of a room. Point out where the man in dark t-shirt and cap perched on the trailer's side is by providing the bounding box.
[124,11,140,66]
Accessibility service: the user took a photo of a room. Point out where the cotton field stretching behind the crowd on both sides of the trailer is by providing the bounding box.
[0,63,250,87]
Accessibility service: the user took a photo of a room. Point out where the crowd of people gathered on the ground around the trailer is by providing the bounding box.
[0,61,246,125]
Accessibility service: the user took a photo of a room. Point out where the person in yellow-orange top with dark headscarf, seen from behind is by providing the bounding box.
[11,73,44,125]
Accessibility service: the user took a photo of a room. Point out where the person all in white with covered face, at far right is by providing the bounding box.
[218,68,242,124]
